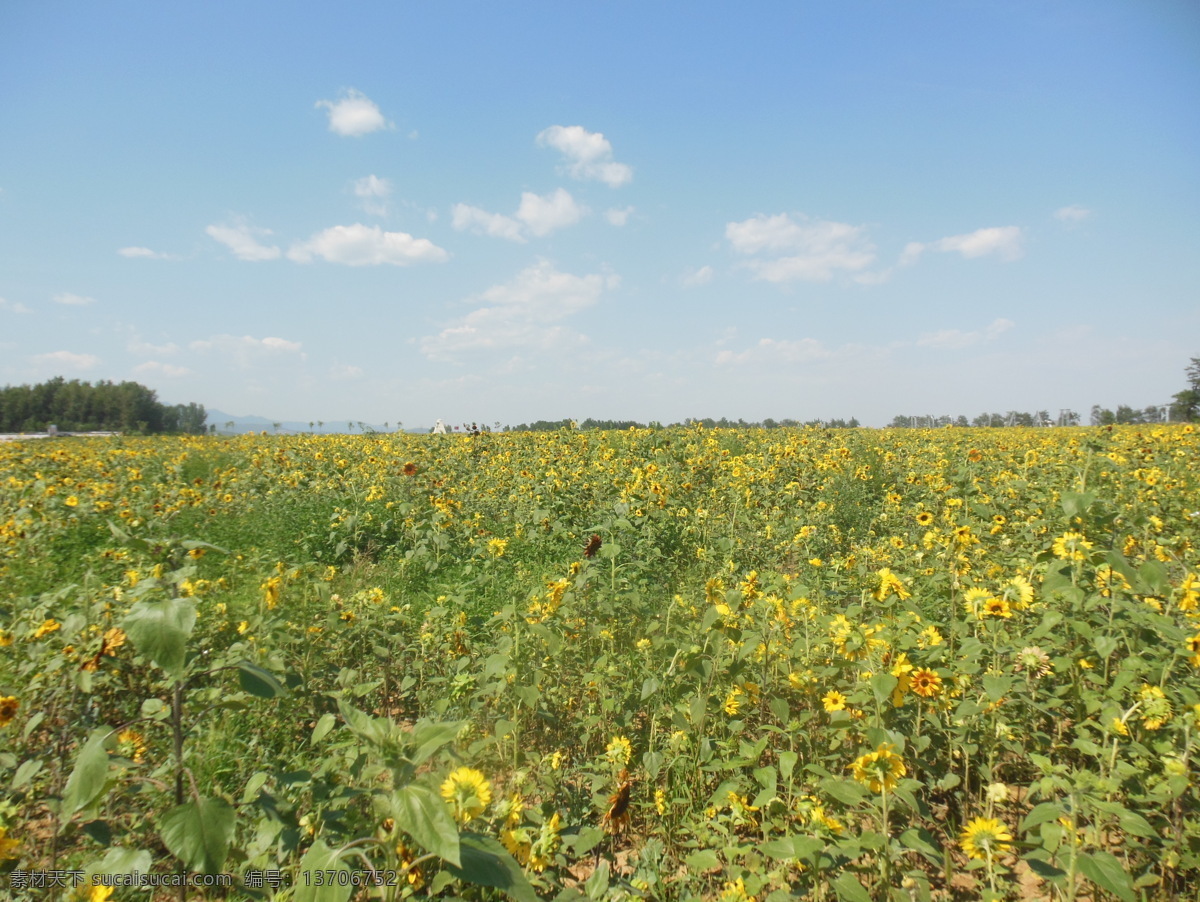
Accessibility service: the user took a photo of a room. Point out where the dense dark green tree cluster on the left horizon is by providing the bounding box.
[0,375,208,434]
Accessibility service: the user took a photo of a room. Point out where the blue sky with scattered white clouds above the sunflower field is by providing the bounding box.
[0,0,1200,426]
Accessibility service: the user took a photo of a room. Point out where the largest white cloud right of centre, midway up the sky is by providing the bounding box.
[725,214,875,282]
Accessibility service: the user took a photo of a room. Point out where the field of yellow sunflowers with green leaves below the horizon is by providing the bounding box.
[0,426,1200,902]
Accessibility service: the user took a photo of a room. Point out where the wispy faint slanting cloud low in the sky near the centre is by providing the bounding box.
[421,260,619,360]
